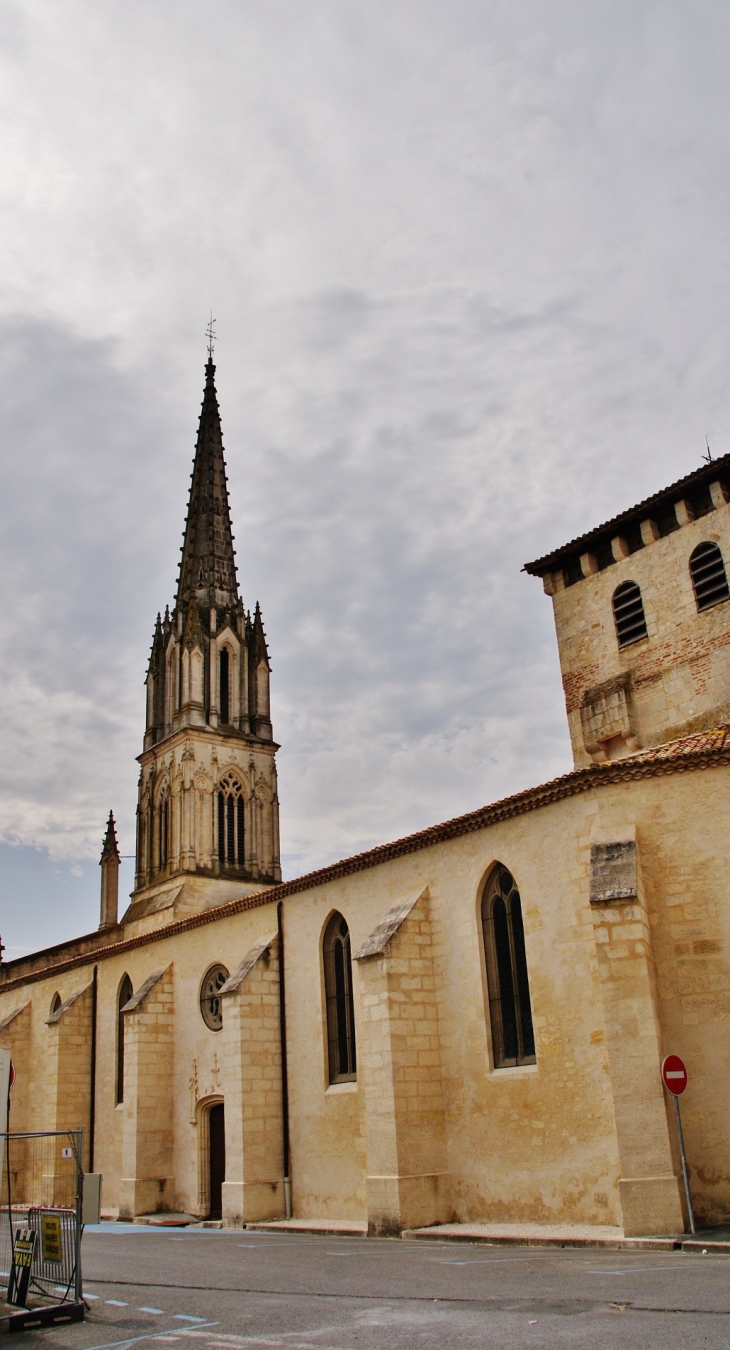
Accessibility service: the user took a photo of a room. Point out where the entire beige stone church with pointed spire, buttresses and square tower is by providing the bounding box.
[0,359,730,1235]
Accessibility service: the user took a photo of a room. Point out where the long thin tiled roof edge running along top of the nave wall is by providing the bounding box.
[0,725,730,994]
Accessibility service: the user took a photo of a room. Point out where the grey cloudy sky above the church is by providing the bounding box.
[0,0,730,956]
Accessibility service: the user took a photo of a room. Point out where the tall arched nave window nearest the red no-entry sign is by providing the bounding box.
[482,863,534,1069]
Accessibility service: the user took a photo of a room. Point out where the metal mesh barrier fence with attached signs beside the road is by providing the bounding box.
[0,1130,84,1307]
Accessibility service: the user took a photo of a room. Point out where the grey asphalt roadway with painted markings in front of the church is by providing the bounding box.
[19,1224,730,1350]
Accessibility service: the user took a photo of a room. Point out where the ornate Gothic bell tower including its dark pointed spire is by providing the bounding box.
[125,351,281,919]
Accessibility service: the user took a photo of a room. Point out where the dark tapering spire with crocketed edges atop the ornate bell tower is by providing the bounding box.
[175,354,239,612]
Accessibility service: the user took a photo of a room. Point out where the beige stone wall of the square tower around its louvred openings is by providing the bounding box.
[546,502,730,768]
